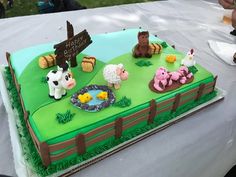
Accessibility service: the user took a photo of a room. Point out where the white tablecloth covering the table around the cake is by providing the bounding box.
[0,0,236,177]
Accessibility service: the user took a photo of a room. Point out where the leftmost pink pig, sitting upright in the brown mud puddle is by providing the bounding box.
[154,67,172,91]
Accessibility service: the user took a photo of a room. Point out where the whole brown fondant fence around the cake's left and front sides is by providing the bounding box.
[4,53,217,166]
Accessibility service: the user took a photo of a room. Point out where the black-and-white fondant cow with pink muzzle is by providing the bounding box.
[47,66,76,100]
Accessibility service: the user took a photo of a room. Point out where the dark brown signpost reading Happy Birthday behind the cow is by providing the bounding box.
[54,21,92,67]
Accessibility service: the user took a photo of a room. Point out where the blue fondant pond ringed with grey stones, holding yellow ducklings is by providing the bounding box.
[71,85,115,112]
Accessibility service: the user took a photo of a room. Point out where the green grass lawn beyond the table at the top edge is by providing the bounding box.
[4,0,155,17]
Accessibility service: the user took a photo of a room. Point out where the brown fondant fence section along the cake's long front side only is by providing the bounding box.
[44,78,217,166]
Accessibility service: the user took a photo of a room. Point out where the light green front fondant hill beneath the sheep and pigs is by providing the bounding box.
[30,49,213,143]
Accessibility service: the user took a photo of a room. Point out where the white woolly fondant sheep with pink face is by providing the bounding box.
[103,64,129,89]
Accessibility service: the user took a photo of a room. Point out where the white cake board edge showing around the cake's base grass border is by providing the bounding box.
[0,65,226,176]
